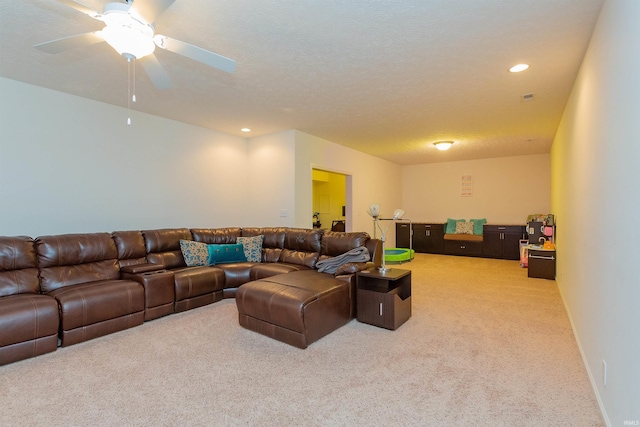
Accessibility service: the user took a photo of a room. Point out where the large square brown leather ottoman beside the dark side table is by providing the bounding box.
[236,270,351,348]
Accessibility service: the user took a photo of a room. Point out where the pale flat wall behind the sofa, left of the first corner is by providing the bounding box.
[0,78,247,237]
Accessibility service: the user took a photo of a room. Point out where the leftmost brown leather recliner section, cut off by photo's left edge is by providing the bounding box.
[0,236,59,366]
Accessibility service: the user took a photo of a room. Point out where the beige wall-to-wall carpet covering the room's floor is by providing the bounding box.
[0,254,604,427]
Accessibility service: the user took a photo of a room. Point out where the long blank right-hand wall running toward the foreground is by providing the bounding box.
[551,0,640,426]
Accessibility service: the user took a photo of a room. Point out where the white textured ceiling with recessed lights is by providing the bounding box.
[0,0,603,165]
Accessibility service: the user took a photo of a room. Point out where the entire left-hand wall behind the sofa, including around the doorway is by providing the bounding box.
[0,78,400,237]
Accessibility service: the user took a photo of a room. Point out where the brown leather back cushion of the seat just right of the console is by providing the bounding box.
[142,228,191,269]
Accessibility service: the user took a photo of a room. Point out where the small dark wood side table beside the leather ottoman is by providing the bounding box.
[356,268,411,330]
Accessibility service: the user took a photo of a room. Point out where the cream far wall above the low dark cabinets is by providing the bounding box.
[402,155,551,224]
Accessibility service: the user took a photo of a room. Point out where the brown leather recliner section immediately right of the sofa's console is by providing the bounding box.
[142,228,224,312]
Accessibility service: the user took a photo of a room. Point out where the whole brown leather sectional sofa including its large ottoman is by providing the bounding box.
[0,228,382,365]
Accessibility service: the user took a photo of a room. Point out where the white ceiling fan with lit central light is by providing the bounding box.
[34,0,236,89]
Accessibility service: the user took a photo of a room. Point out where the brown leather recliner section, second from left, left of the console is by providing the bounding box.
[36,233,144,347]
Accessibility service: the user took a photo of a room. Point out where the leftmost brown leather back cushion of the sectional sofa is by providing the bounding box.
[0,236,40,297]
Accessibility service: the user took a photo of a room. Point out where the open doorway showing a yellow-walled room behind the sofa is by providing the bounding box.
[312,168,347,231]
